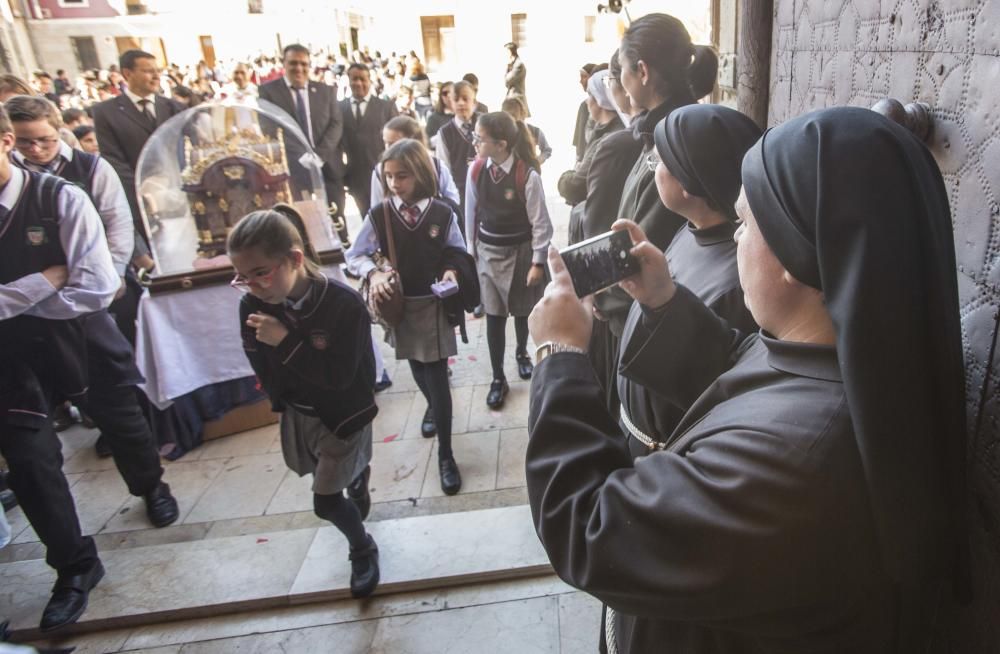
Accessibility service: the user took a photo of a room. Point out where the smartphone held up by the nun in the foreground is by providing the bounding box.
[559,230,639,297]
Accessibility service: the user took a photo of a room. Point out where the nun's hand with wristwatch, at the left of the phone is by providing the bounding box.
[528,245,594,350]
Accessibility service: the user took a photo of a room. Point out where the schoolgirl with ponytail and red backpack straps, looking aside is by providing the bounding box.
[465,112,552,409]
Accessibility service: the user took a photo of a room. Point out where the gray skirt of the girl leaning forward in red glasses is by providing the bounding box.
[281,406,372,495]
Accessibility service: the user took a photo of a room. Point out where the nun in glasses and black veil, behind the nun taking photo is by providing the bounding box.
[618,104,761,456]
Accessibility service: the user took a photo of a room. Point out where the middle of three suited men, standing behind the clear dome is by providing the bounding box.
[260,43,348,245]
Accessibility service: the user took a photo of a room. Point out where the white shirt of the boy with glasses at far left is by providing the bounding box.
[12,143,135,277]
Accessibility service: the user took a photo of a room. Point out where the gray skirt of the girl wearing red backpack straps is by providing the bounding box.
[476,241,548,317]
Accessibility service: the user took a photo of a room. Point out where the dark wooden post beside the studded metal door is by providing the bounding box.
[736,0,774,128]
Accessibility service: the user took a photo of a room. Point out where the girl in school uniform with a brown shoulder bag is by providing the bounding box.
[346,139,475,495]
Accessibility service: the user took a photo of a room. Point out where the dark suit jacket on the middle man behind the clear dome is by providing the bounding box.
[260,77,345,182]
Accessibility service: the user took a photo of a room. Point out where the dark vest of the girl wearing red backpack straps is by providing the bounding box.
[476,160,531,246]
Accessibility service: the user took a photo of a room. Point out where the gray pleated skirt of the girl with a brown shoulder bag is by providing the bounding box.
[385,295,458,363]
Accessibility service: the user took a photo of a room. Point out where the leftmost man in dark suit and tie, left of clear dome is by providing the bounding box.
[94,50,184,254]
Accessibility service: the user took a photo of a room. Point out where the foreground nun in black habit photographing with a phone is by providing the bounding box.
[526,108,966,654]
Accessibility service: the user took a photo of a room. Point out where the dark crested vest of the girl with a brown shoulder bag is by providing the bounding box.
[372,199,452,297]
